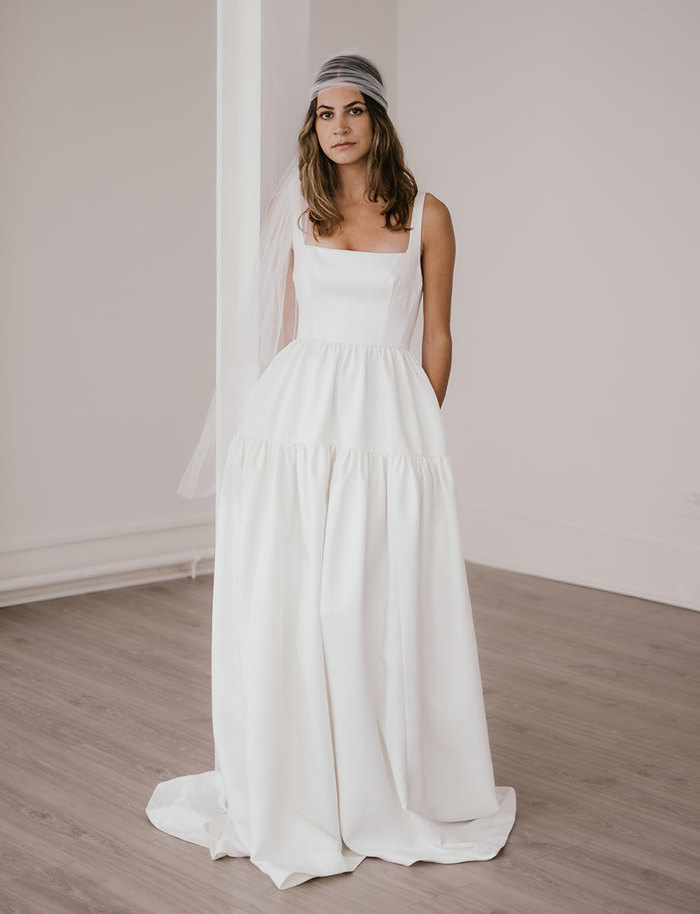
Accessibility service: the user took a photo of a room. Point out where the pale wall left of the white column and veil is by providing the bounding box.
[0,0,216,601]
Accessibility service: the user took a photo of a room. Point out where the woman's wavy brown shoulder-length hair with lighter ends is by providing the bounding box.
[297,57,418,241]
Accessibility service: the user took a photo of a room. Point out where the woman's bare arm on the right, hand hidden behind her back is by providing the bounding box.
[421,193,456,407]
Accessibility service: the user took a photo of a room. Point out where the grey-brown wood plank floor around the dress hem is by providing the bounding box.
[0,565,700,914]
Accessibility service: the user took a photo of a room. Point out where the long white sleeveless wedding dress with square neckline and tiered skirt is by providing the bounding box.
[146,191,515,889]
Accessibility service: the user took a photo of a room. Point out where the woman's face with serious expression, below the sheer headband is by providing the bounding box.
[315,86,373,165]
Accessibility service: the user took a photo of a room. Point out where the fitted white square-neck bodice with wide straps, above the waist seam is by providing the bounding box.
[293,191,425,349]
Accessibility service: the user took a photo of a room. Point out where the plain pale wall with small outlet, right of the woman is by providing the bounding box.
[397,0,700,609]
